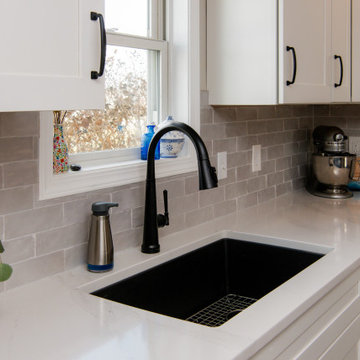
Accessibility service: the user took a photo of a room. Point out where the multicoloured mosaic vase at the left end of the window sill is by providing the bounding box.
[53,111,69,174]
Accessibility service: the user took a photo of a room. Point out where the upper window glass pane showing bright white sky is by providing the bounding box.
[105,0,150,37]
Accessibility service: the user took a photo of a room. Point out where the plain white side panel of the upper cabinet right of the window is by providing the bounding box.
[207,0,277,105]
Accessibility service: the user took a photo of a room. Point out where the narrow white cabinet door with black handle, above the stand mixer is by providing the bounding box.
[330,0,351,102]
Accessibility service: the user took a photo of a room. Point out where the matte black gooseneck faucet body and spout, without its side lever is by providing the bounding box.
[141,121,218,254]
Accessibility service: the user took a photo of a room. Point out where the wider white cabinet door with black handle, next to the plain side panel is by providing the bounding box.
[279,0,331,103]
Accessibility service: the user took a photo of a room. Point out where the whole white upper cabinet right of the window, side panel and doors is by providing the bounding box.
[207,0,352,105]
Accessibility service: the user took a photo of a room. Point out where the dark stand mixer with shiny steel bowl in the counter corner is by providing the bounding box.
[306,126,356,199]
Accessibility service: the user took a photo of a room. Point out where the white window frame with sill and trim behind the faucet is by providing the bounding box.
[39,0,200,200]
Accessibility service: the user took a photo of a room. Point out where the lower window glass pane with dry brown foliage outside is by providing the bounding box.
[64,45,159,154]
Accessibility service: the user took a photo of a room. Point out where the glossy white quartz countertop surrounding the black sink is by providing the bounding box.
[0,190,360,360]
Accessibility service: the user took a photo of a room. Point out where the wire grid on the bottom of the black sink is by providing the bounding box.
[186,294,258,327]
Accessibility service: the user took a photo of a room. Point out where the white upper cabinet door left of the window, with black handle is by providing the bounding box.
[0,0,104,111]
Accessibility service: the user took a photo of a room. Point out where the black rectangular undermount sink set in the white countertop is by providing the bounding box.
[92,239,324,326]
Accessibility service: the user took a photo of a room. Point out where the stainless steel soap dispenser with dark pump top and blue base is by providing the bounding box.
[87,202,119,272]
